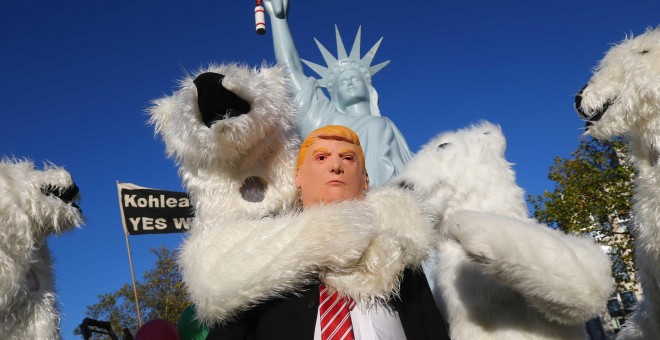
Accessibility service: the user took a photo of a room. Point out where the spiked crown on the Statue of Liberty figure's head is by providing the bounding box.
[301,25,390,96]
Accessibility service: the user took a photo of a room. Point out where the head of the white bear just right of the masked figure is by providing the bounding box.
[393,121,527,218]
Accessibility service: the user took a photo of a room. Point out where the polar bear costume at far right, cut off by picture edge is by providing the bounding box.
[575,28,660,339]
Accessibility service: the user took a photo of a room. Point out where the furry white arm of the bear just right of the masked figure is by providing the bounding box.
[442,210,614,324]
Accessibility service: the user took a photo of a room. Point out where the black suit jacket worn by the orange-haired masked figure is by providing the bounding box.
[206,269,449,340]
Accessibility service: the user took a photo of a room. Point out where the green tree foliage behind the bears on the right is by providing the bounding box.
[528,138,635,290]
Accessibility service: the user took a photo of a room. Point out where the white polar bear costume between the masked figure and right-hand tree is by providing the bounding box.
[394,122,613,340]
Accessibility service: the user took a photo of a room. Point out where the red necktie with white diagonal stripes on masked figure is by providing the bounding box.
[319,284,355,340]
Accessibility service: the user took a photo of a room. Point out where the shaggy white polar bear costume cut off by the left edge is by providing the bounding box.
[0,160,82,340]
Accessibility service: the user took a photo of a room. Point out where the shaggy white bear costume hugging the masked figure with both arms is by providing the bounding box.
[150,65,433,323]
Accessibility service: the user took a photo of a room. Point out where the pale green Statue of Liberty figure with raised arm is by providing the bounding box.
[264,0,412,186]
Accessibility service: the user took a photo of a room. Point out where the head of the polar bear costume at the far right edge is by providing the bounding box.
[575,27,660,164]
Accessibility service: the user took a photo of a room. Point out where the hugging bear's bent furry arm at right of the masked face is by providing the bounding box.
[323,187,435,304]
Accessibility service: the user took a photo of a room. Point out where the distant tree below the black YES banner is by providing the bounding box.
[74,246,190,339]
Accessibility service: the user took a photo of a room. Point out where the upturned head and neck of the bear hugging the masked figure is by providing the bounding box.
[149,64,299,219]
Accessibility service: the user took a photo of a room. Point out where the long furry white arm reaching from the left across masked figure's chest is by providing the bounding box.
[179,201,377,323]
